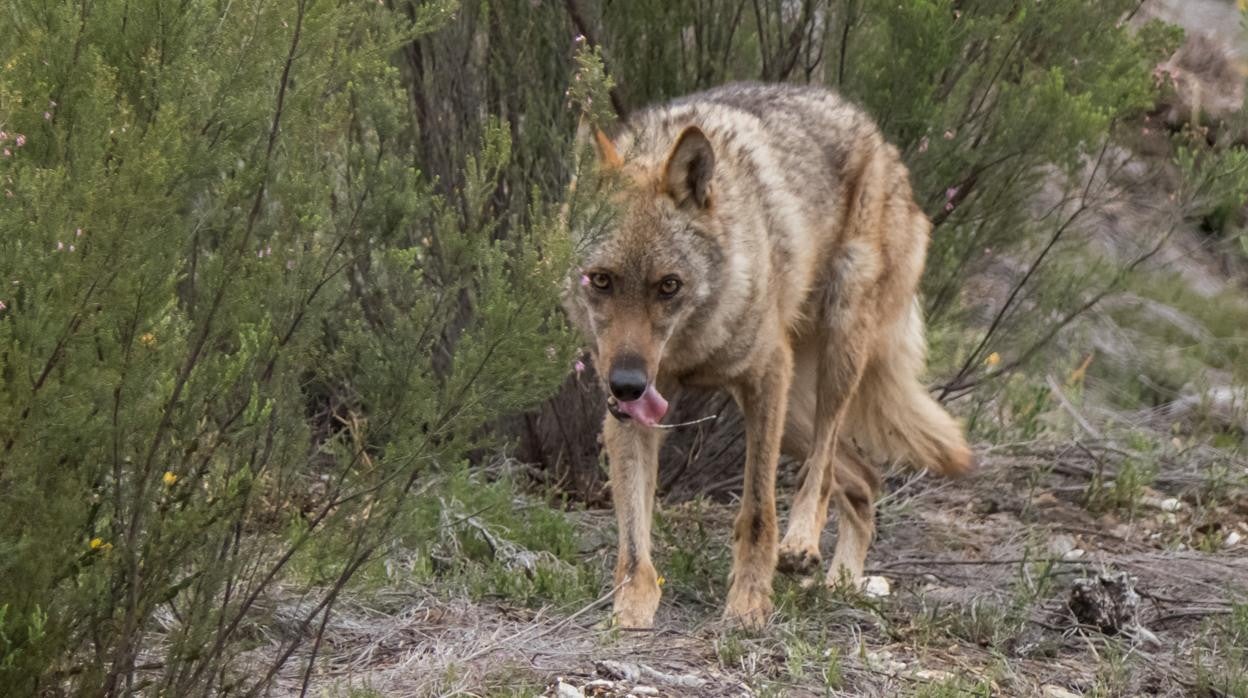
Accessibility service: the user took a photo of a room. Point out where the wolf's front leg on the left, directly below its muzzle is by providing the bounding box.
[603,415,663,628]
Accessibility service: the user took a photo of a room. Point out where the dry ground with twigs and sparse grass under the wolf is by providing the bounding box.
[255,442,1248,697]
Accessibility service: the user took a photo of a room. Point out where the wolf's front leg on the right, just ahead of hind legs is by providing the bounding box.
[724,347,792,628]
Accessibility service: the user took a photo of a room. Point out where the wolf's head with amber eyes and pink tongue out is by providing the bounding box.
[569,126,724,426]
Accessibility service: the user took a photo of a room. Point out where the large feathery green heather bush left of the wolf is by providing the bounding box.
[0,0,572,696]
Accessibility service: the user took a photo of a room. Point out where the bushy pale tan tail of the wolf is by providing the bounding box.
[846,303,975,476]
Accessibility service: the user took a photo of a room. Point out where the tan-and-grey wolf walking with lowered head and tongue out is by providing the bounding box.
[564,84,973,628]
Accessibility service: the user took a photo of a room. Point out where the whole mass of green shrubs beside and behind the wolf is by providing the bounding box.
[0,0,1242,696]
